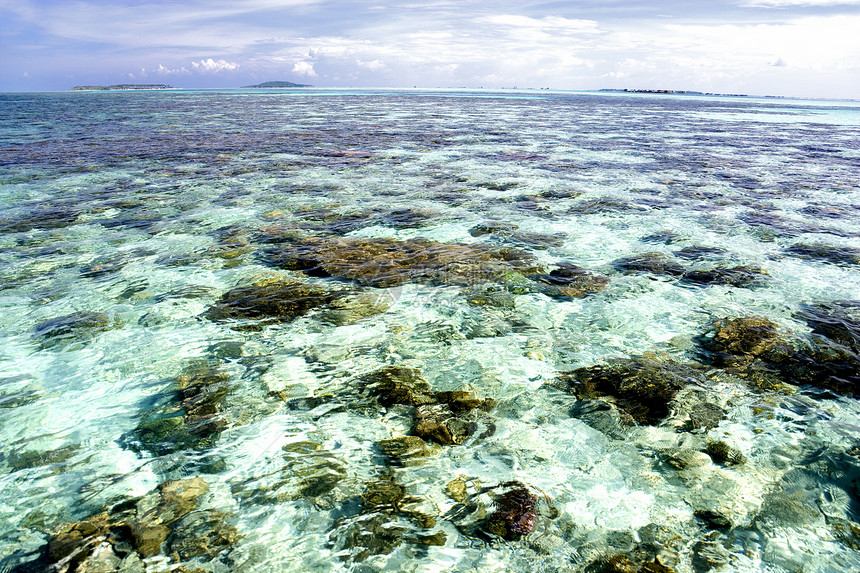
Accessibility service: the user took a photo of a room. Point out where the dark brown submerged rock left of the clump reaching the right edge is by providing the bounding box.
[559,356,703,425]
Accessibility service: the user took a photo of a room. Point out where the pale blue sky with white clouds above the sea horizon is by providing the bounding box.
[0,0,860,99]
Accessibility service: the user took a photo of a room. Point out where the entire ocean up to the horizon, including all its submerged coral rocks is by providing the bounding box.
[0,88,860,573]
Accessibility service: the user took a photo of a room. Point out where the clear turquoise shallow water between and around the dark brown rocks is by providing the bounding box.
[0,90,860,572]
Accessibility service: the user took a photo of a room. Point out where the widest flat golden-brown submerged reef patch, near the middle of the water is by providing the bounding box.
[267,237,540,287]
